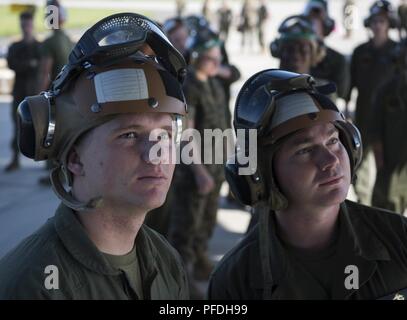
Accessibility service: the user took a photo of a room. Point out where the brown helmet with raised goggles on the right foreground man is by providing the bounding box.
[225,69,362,209]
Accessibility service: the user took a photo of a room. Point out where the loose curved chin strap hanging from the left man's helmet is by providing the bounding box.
[50,166,103,211]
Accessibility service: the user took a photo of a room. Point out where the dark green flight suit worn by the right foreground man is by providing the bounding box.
[207,201,407,300]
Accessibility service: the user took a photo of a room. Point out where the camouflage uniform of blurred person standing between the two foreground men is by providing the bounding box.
[168,70,227,272]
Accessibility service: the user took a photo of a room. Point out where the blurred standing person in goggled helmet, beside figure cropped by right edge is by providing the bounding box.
[346,0,397,205]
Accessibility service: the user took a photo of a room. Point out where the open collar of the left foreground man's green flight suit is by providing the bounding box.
[54,203,157,284]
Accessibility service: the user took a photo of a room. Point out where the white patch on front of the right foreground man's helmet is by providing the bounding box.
[271,92,319,128]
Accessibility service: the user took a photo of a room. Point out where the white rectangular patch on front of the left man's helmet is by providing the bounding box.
[94,68,148,103]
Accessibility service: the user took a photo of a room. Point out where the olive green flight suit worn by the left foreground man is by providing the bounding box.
[0,204,189,300]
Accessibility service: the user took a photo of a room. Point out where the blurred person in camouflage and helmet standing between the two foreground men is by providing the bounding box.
[168,33,228,299]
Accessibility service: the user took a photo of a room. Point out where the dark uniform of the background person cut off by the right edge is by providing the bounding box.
[372,74,407,213]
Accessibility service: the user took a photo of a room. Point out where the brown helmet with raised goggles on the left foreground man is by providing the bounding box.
[17,13,187,210]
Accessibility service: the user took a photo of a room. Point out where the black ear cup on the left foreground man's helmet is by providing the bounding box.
[17,99,36,159]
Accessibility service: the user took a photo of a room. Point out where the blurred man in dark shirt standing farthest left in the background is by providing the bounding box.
[5,12,40,172]
